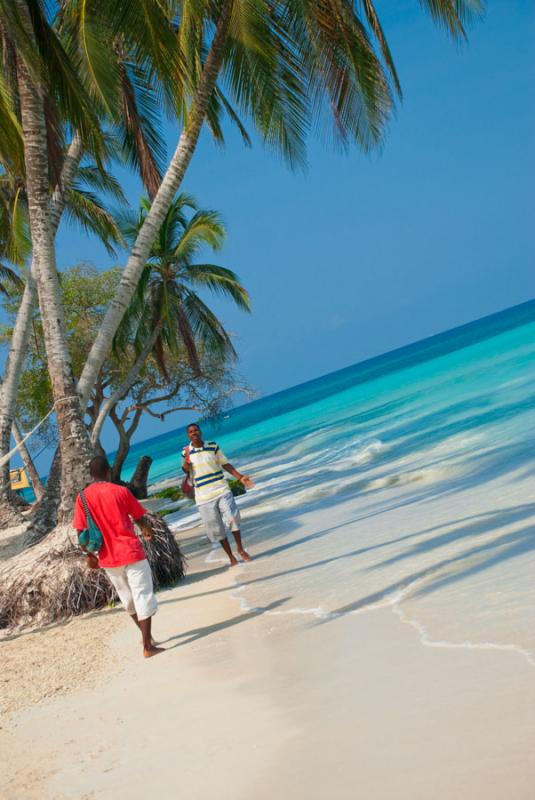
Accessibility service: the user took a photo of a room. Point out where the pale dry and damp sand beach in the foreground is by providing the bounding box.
[0,488,535,800]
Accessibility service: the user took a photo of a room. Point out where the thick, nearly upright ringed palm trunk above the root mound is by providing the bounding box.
[17,34,91,521]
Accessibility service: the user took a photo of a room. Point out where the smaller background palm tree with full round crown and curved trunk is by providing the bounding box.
[91,194,251,445]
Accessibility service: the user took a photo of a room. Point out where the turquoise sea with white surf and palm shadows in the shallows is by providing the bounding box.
[122,301,535,665]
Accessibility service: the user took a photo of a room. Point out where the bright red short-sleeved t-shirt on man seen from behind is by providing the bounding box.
[72,481,147,567]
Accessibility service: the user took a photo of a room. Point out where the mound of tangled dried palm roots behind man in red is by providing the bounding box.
[0,514,186,630]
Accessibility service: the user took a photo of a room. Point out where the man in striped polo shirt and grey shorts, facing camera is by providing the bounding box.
[182,424,254,567]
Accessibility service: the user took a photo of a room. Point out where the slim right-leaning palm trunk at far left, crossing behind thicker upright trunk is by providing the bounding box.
[0,133,83,506]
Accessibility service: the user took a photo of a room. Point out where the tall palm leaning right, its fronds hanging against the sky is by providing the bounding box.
[79,0,483,403]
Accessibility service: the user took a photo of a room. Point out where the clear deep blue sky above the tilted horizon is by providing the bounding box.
[53,0,535,450]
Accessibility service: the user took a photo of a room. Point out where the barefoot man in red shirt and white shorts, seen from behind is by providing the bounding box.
[73,456,163,658]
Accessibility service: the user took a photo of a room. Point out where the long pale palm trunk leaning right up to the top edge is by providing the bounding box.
[78,0,234,408]
